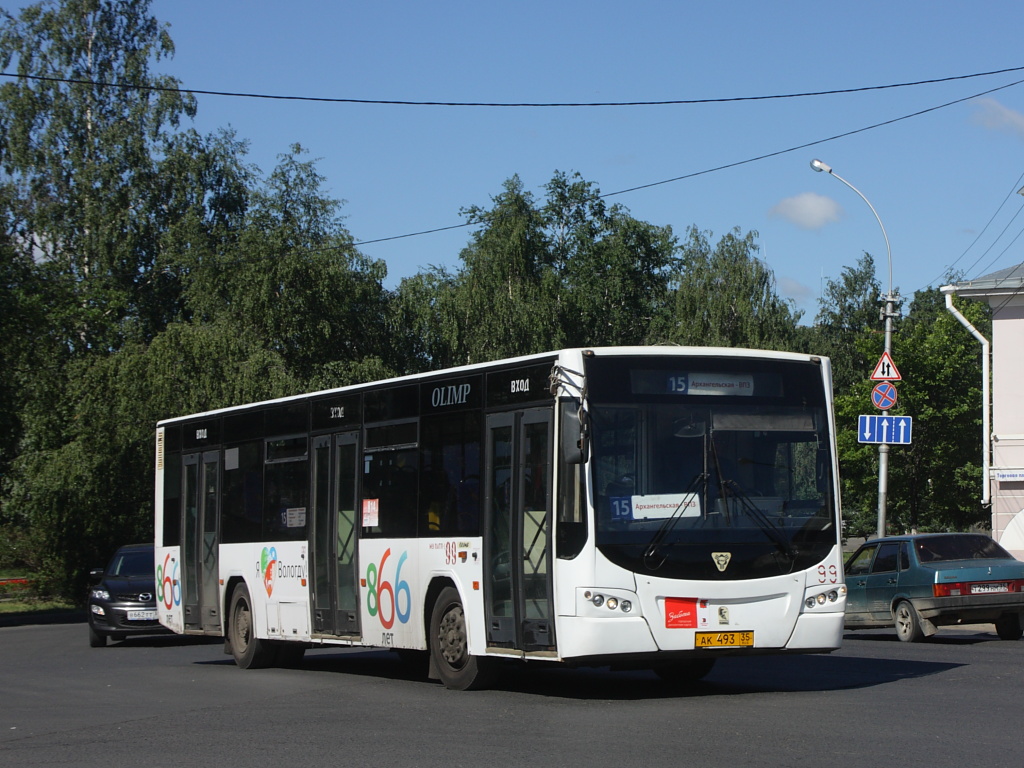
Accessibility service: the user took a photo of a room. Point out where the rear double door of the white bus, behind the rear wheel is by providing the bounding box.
[181,451,222,634]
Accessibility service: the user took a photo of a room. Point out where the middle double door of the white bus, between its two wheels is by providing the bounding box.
[312,432,359,637]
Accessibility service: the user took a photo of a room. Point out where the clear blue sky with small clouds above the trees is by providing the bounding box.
[144,0,1024,322]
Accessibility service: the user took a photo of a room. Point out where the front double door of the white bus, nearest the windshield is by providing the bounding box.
[484,409,555,651]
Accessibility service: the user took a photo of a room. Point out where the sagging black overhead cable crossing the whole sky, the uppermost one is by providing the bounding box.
[0,67,1024,108]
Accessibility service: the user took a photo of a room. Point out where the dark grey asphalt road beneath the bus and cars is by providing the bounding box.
[0,624,1024,768]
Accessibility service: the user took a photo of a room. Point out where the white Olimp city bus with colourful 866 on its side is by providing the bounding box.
[156,347,846,689]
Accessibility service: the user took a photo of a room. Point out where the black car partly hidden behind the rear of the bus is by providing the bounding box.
[89,544,168,648]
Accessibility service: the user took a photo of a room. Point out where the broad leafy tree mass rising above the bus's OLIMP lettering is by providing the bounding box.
[395,172,677,370]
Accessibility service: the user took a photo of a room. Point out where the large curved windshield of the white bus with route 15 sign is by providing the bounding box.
[588,358,838,581]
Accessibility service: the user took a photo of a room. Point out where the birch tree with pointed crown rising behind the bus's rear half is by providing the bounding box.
[183,145,394,386]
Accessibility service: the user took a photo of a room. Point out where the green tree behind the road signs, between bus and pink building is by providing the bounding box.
[836,289,990,534]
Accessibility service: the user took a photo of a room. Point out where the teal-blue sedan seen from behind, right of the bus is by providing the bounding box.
[846,534,1024,642]
